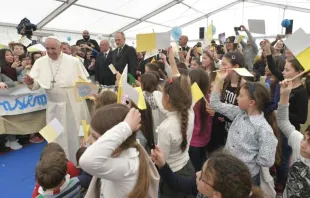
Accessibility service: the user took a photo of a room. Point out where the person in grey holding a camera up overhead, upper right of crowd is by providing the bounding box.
[235,25,258,71]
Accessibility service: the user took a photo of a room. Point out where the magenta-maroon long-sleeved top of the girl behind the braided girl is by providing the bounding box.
[190,95,213,147]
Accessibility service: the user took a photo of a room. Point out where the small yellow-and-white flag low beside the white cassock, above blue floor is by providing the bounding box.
[39,118,64,143]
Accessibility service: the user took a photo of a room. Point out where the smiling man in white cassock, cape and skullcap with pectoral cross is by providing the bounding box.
[24,37,90,162]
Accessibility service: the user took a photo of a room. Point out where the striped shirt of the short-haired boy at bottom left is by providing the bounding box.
[37,177,81,198]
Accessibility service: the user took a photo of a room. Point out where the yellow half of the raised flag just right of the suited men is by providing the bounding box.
[136,33,156,52]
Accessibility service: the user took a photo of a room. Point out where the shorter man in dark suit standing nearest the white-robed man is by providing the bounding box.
[95,40,116,85]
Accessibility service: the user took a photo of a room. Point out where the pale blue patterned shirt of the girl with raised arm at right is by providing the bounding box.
[210,93,278,177]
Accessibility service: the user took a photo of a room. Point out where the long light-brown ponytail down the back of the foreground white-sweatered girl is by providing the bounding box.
[128,144,151,198]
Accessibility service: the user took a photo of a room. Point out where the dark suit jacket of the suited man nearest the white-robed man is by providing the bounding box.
[95,50,115,85]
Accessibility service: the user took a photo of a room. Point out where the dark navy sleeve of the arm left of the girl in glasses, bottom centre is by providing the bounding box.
[158,163,198,196]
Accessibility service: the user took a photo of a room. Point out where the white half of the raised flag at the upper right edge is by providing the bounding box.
[284,28,310,56]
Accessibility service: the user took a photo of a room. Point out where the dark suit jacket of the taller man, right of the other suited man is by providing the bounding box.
[112,45,138,76]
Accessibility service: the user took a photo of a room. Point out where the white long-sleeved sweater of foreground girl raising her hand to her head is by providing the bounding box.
[80,122,140,198]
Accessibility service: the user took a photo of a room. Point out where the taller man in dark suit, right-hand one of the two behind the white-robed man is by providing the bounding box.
[112,32,138,76]
